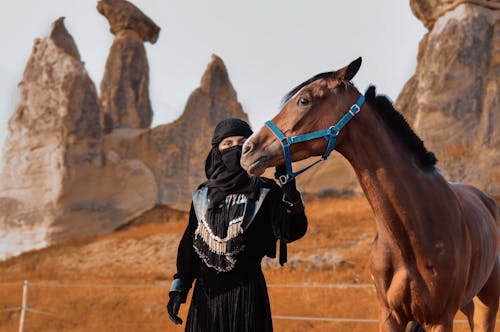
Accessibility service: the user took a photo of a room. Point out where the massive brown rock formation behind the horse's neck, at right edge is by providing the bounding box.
[396,0,500,197]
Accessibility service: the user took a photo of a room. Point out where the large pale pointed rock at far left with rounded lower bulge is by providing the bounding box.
[0,18,157,259]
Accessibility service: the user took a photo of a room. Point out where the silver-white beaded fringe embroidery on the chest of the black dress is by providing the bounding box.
[193,194,248,272]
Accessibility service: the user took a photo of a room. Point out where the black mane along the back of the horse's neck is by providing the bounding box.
[365,85,437,168]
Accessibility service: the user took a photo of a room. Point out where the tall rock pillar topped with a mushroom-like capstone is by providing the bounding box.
[97,0,160,133]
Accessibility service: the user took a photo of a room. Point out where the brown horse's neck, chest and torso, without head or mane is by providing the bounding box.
[338,92,498,330]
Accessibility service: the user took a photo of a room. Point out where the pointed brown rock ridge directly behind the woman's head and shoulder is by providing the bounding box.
[104,55,248,211]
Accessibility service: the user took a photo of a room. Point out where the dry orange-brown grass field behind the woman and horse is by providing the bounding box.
[0,197,498,332]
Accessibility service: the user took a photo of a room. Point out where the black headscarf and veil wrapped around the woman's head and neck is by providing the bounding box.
[204,118,260,209]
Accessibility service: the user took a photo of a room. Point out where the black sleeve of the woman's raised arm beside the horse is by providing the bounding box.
[269,183,307,243]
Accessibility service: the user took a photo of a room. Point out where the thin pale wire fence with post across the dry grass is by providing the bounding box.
[0,281,492,332]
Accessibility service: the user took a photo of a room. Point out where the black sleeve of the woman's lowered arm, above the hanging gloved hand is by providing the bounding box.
[174,203,200,285]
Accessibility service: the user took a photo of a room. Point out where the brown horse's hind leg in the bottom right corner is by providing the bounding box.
[474,259,500,332]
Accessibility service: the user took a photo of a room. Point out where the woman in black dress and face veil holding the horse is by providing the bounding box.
[167,119,307,332]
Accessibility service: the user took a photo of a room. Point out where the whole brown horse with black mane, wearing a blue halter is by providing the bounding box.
[241,58,500,331]
